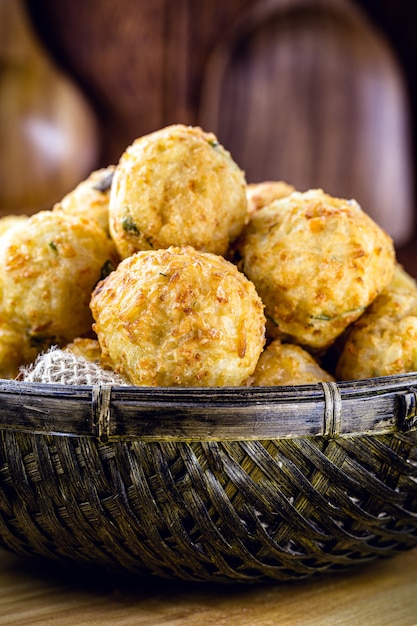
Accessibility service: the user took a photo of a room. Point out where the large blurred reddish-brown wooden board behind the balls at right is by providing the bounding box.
[199,0,415,246]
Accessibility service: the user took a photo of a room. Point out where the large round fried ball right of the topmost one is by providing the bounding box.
[236,189,395,352]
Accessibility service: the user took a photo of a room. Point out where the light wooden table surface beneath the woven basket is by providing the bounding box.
[0,550,417,626]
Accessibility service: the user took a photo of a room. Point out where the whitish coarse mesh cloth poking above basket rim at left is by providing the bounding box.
[19,347,129,385]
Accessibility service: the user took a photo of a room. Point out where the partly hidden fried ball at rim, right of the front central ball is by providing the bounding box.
[250,339,334,387]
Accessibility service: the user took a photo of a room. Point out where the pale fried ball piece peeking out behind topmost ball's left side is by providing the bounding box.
[53,165,115,233]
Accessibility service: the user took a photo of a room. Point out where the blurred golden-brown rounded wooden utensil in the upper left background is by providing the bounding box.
[0,0,98,215]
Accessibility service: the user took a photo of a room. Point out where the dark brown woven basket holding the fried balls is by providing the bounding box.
[0,373,417,582]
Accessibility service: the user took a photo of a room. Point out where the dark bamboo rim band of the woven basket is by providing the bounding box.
[0,372,417,441]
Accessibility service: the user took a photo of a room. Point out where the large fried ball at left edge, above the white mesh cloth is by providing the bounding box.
[0,211,115,350]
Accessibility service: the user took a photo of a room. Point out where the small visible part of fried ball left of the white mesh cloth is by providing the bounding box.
[0,320,38,378]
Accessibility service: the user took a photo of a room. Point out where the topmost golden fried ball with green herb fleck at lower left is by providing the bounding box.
[109,124,247,258]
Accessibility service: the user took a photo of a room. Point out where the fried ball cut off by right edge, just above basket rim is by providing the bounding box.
[336,266,417,380]
